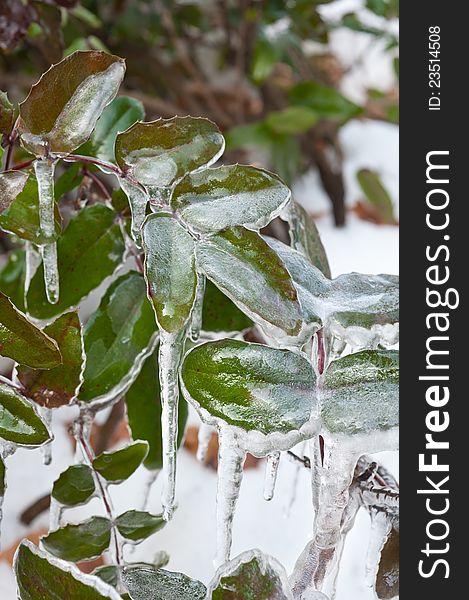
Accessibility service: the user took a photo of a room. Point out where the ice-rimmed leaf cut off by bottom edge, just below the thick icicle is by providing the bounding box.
[208,550,293,600]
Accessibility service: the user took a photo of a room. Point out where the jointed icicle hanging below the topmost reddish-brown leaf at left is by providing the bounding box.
[34,159,59,304]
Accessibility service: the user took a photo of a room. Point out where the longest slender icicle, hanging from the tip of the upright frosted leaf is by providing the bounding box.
[159,330,184,521]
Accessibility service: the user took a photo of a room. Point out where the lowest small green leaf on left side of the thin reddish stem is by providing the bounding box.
[41,517,112,562]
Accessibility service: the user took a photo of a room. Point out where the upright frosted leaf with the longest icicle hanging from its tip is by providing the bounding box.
[143,213,197,333]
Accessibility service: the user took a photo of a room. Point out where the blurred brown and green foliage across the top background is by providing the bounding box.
[0,0,399,226]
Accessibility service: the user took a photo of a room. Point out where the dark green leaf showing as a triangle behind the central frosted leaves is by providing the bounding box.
[202,280,253,332]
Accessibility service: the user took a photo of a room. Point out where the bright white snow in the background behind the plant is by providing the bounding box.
[0,0,398,600]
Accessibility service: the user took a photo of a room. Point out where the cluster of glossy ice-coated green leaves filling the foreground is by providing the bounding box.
[0,51,398,600]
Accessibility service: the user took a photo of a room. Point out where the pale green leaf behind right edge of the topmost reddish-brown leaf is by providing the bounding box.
[79,96,145,162]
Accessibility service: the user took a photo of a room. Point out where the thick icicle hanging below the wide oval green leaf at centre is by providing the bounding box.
[214,425,246,568]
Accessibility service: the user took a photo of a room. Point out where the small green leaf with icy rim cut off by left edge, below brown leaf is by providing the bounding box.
[0,383,52,446]
